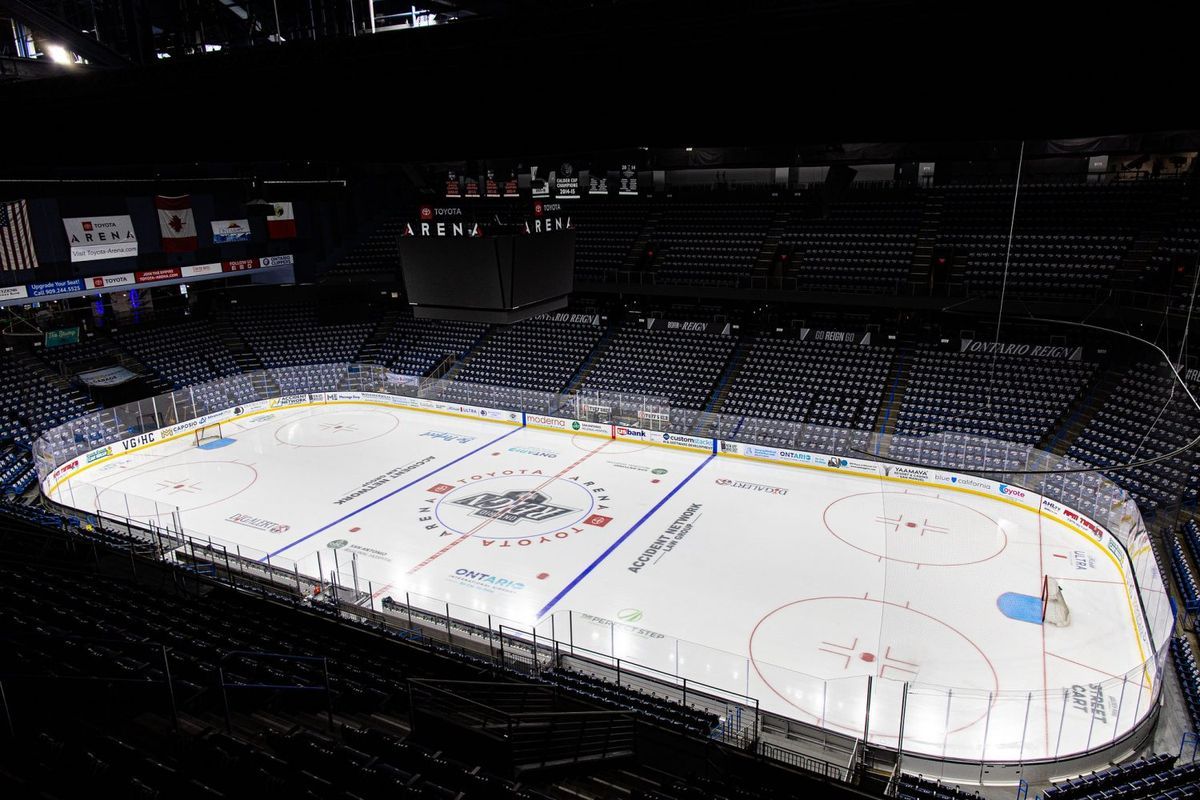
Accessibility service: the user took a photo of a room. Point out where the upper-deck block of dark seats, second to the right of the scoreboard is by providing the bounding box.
[650,200,775,287]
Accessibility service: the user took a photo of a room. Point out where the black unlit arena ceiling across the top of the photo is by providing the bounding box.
[0,0,1200,164]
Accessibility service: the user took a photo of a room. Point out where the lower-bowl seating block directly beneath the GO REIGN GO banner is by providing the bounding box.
[716,337,893,434]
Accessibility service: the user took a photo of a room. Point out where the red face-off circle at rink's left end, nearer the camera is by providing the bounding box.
[97,461,258,519]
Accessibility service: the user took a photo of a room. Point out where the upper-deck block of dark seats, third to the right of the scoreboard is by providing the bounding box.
[780,187,922,294]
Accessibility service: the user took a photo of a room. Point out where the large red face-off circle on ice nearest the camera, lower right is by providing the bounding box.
[750,596,1000,746]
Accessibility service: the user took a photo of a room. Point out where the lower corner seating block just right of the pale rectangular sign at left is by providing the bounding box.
[115,319,246,389]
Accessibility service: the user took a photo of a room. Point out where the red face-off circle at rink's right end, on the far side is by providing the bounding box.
[822,492,1008,566]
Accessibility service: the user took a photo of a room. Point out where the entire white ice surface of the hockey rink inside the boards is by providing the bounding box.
[44,403,1154,760]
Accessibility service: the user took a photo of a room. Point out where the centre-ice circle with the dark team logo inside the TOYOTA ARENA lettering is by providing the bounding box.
[428,474,608,540]
